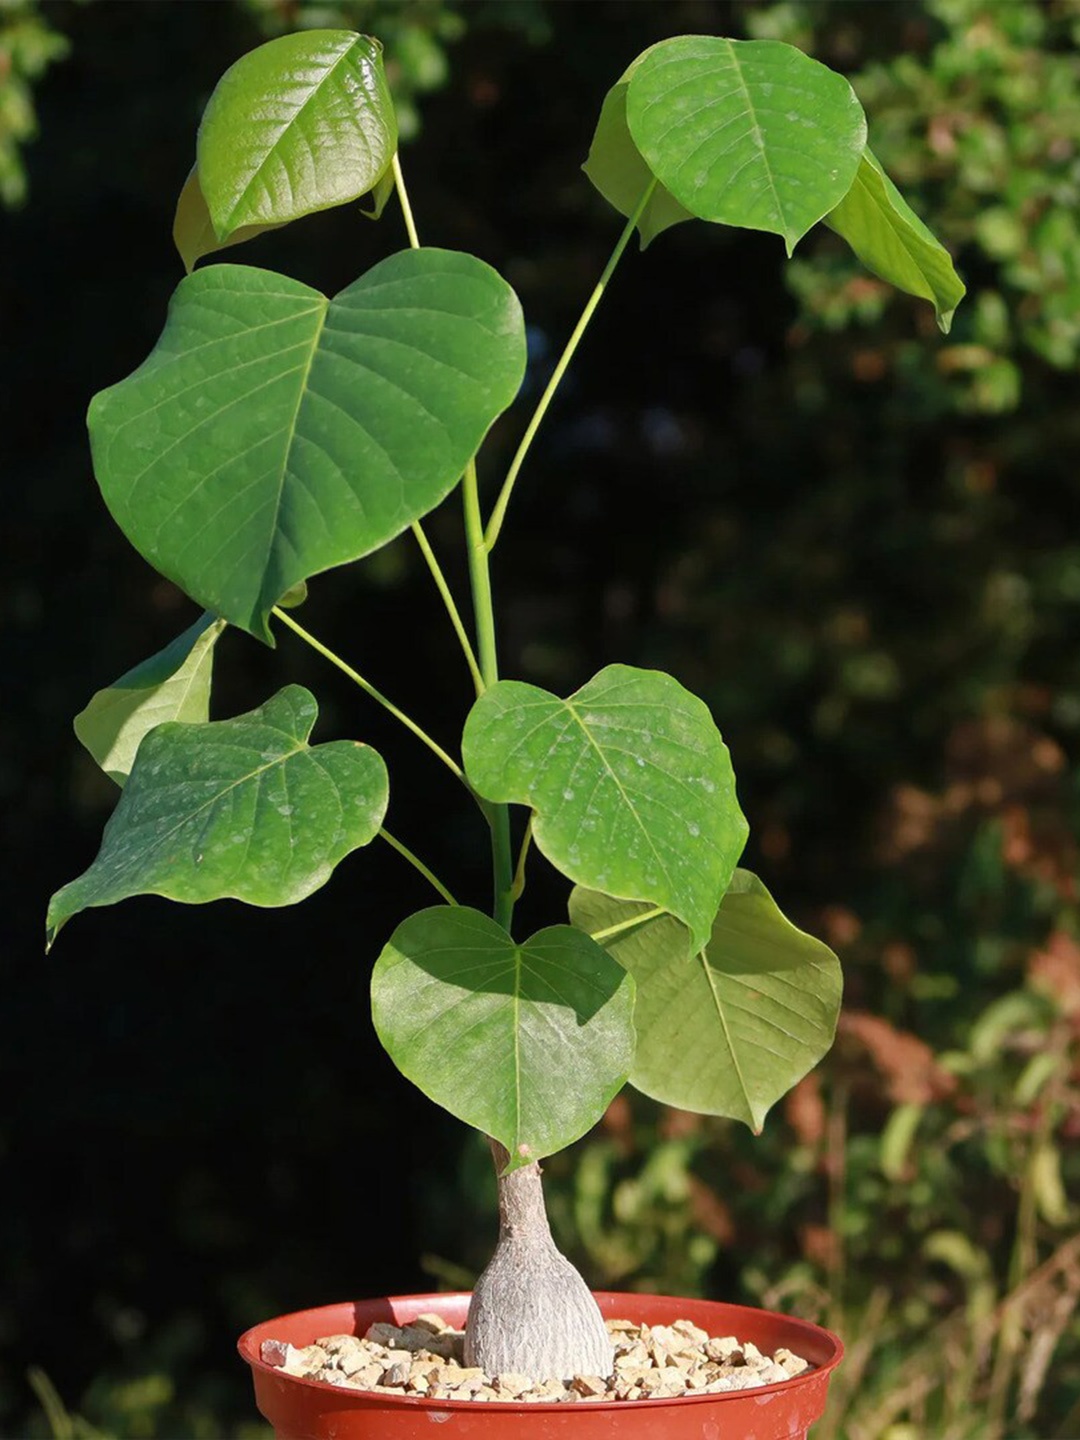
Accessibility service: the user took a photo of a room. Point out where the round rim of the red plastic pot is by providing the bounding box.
[236,1290,844,1411]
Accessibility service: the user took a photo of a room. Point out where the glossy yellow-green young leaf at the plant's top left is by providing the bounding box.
[196,30,397,240]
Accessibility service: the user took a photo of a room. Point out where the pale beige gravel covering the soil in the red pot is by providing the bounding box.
[262,1315,812,1404]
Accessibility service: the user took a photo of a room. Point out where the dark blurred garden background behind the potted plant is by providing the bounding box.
[0,0,1080,1440]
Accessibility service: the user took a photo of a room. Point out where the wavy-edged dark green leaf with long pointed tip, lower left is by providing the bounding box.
[46,685,387,945]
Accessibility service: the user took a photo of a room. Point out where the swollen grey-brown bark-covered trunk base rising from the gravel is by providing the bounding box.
[465,1140,613,1381]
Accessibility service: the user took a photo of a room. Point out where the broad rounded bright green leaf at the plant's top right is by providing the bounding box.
[626,35,867,255]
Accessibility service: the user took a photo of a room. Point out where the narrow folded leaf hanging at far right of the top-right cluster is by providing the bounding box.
[825,148,966,336]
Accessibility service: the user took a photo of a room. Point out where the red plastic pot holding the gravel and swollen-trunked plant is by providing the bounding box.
[239,1292,844,1440]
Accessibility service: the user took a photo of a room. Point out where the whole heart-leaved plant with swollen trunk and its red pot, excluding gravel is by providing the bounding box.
[48,30,963,1437]
